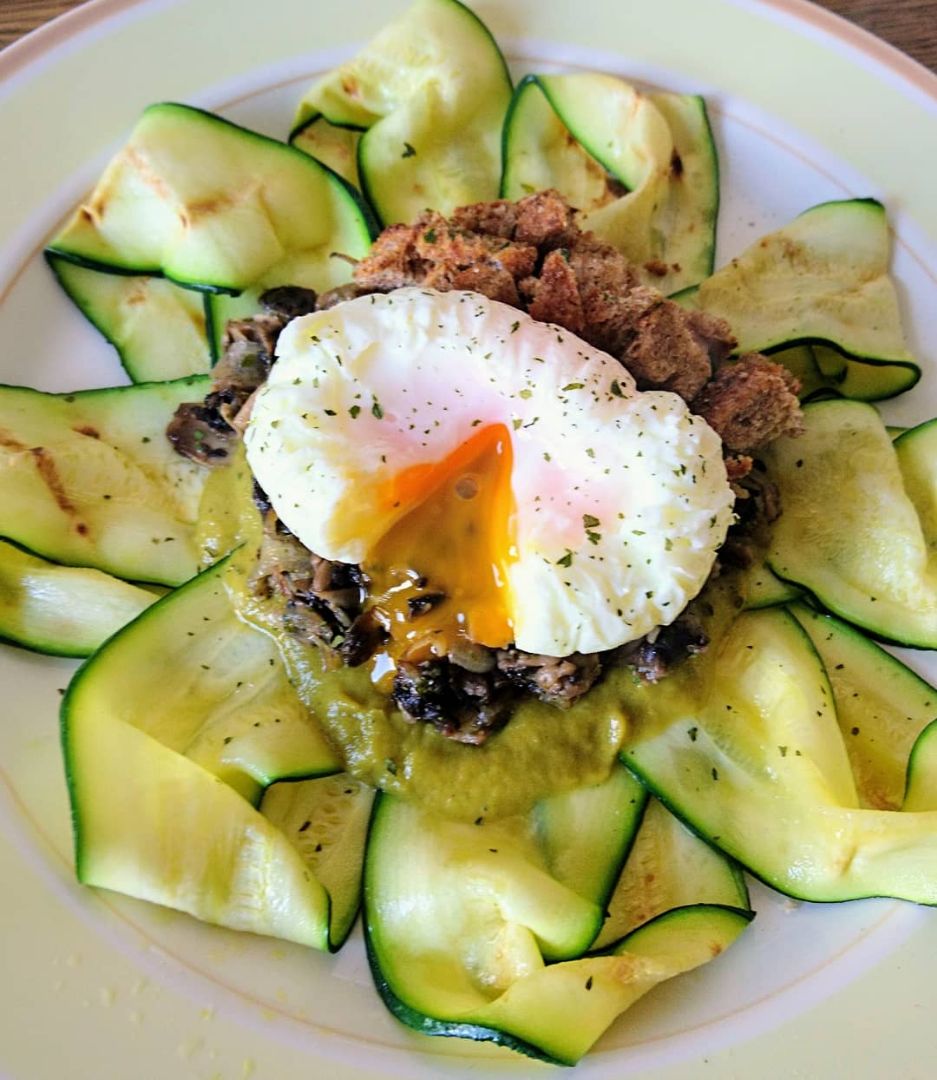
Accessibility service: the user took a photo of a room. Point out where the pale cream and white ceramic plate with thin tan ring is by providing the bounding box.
[0,0,937,1080]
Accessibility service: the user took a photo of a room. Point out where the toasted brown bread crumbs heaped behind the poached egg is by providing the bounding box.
[351,191,800,454]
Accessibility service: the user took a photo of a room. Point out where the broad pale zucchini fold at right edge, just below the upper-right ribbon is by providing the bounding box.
[764,401,937,648]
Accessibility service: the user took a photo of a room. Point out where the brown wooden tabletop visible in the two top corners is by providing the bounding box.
[0,0,937,71]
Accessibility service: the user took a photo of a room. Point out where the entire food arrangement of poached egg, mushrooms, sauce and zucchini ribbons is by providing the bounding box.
[0,0,937,1065]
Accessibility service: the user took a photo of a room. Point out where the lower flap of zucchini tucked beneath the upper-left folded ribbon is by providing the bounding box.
[47,253,212,382]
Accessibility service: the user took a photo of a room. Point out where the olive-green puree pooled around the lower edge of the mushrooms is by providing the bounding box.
[202,453,738,821]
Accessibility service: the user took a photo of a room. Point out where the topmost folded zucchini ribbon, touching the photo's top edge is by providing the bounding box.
[295,0,511,225]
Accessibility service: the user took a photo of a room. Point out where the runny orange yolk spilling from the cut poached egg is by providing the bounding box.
[363,423,514,680]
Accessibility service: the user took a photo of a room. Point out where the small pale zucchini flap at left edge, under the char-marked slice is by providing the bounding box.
[0,540,157,657]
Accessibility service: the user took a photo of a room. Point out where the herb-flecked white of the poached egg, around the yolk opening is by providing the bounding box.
[245,288,734,656]
